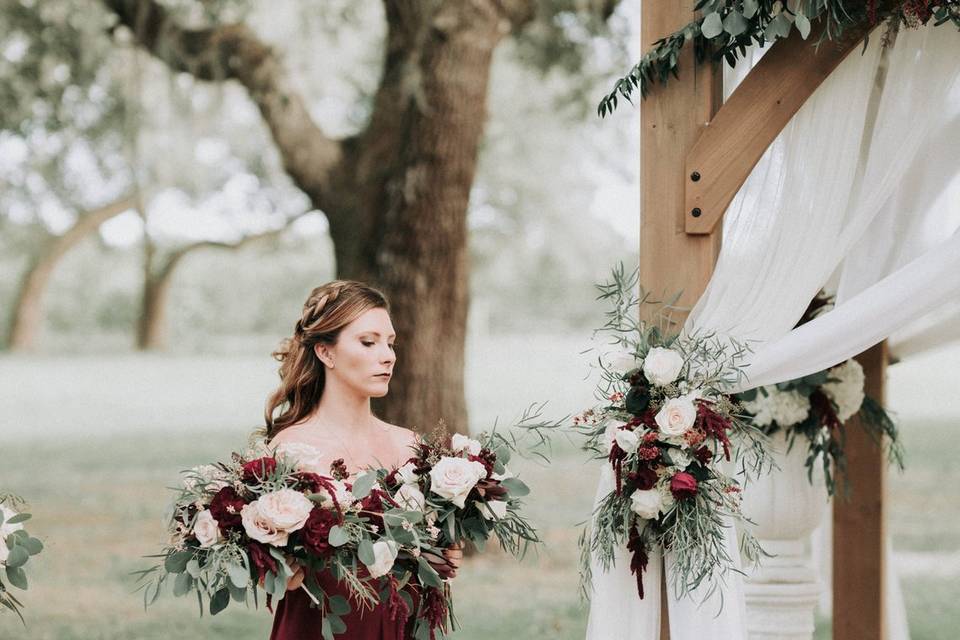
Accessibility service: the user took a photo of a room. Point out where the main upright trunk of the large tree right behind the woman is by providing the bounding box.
[346,3,505,432]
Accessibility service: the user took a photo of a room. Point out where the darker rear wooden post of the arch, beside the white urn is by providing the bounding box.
[833,342,889,640]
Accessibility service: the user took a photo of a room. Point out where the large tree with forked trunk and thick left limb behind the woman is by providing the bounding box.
[104,0,616,430]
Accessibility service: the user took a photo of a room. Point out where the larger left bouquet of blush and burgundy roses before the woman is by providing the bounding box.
[136,444,458,640]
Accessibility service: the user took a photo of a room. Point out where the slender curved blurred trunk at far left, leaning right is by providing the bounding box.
[7,197,134,351]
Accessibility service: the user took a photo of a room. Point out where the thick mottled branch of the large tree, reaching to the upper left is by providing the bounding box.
[104,0,344,216]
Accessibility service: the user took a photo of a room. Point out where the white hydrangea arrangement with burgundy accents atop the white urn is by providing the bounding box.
[738,360,903,495]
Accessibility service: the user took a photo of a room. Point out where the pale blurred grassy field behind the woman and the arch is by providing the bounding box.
[0,338,960,640]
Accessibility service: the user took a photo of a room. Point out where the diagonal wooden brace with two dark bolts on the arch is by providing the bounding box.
[688,25,866,234]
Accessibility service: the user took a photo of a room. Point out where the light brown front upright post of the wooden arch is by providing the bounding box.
[640,0,722,640]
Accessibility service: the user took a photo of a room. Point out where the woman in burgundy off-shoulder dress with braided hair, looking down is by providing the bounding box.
[265,280,461,640]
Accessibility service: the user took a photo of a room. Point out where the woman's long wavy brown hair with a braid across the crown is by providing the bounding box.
[264,280,390,440]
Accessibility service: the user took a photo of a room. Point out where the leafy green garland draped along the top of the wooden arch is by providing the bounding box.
[597,0,960,117]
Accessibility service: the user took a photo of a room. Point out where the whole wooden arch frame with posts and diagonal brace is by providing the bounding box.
[640,6,888,640]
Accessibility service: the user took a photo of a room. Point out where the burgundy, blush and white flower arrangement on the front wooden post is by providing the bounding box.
[574,272,764,598]
